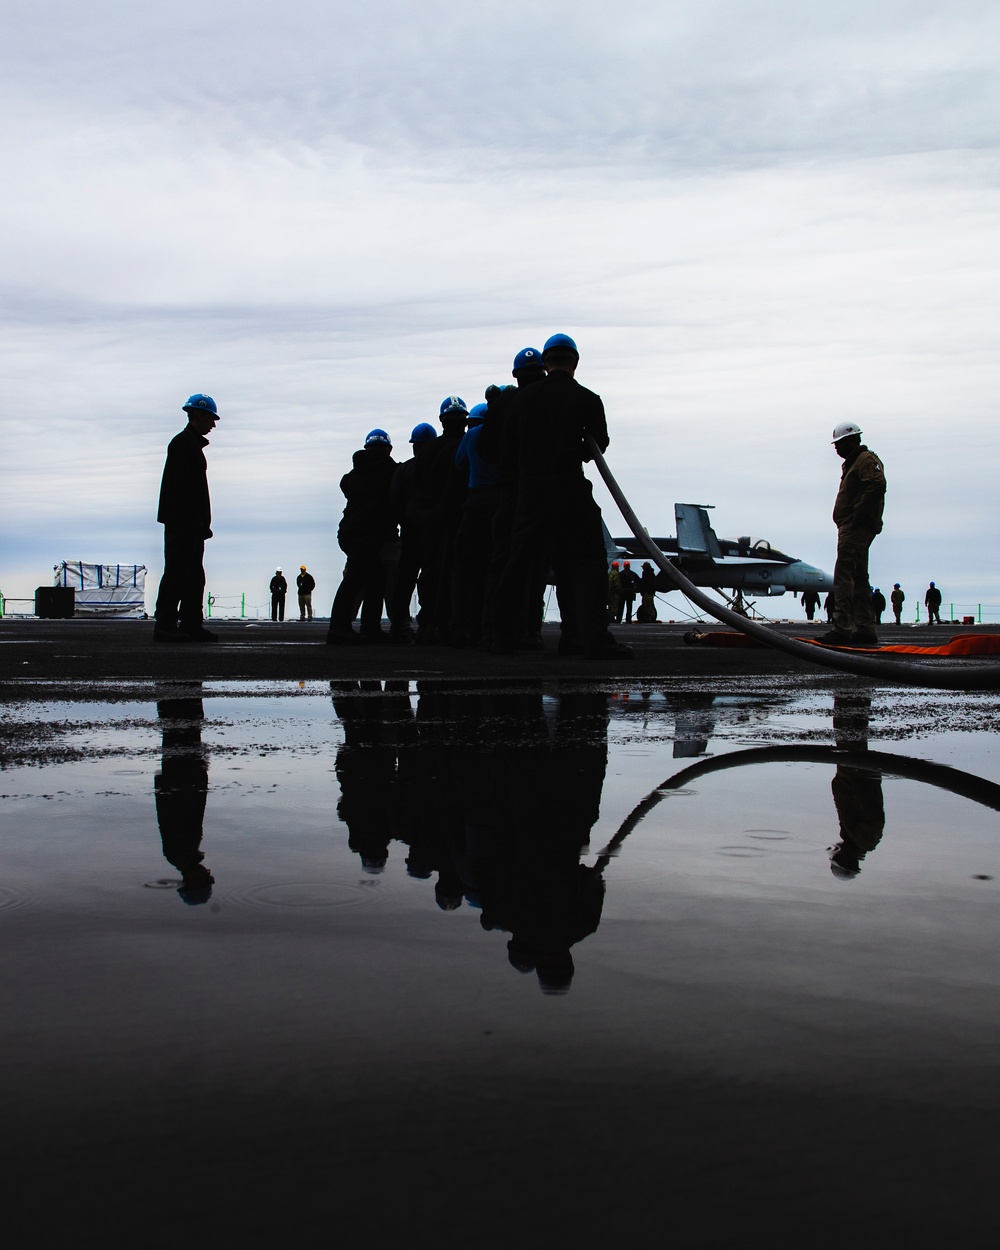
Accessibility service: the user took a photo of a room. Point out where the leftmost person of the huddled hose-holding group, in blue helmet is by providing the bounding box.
[326,430,399,646]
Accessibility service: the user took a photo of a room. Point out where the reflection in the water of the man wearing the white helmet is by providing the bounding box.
[830,691,885,881]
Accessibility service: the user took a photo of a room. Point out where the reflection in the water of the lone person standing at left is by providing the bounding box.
[153,685,215,905]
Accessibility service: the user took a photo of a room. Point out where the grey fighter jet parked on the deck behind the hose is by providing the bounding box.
[604,504,834,598]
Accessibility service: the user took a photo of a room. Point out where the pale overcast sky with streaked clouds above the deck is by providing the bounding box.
[0,0,1000,611]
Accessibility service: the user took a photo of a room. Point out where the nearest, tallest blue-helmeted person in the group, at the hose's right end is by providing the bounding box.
[494,334,633,660]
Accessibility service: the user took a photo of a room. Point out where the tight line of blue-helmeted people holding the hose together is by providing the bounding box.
[326,334,633,659]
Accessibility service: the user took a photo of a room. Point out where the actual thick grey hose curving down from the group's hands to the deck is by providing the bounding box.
[585,434,1000,690]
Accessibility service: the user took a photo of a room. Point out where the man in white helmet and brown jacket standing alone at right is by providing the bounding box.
[820,421,885,646]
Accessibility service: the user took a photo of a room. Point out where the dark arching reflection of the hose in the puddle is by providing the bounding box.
[600,746,1000,864]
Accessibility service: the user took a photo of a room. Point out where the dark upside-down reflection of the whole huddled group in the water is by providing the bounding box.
[331,681,608,994]
